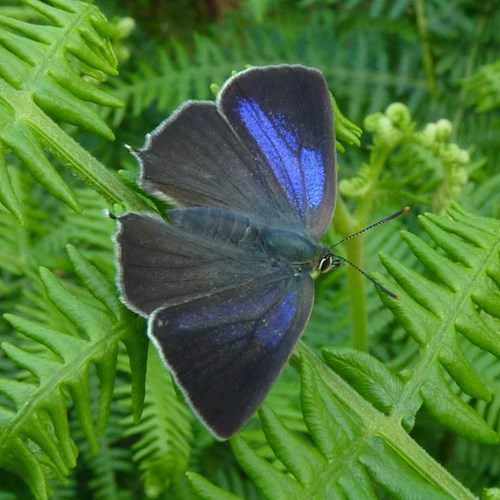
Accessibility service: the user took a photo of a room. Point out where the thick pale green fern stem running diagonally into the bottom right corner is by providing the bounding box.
[291,342,476,500]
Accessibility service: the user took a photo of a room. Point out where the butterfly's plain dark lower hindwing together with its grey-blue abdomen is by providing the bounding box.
[116,208,282,316]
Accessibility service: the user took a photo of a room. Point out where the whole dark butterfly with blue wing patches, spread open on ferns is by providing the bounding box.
[116,65,339,439]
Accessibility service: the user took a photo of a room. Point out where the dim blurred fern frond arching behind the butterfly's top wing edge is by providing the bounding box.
[111,11,424,126]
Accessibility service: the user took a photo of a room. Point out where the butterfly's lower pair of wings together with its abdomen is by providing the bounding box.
[116,208,314,438]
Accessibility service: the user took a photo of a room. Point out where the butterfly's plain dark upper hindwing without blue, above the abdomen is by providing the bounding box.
[136,102,297,225]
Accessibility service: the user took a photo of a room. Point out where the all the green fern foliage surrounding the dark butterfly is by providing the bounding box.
[0,0,500,499]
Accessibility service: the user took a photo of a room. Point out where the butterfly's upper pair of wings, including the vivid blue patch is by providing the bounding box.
[137,66,335,236]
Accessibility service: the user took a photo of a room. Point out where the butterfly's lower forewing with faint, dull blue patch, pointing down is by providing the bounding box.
[149,274,314,439]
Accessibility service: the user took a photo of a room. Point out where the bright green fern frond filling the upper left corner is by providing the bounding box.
[0,0,146,222]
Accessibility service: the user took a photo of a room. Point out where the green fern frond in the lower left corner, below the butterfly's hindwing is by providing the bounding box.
[0,247,145,498]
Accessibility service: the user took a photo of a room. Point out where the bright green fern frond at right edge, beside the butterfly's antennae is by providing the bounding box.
[381,206,500,443]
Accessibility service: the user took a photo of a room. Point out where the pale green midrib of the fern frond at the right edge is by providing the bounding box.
[391,225,500,422]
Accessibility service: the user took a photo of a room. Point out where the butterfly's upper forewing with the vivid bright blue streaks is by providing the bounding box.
[218,66,336,237]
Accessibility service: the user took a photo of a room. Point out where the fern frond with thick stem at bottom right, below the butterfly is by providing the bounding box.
[221,347,473,499]
